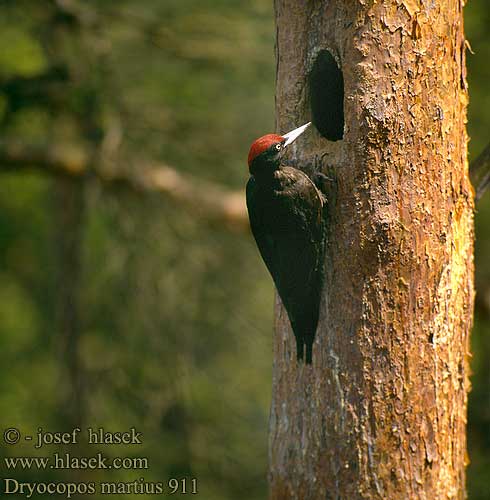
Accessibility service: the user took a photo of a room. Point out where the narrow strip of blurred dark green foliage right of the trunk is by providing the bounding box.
[465,0,490,500]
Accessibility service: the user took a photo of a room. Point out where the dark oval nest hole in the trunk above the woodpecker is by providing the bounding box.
[309,50,344,141]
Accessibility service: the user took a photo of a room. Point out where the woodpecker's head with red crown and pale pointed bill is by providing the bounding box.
[248,123,311,175]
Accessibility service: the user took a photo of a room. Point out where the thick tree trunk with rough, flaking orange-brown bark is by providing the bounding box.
[269,0,474,500]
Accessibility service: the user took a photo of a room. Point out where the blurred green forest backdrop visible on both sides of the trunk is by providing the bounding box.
[0,0,490,500]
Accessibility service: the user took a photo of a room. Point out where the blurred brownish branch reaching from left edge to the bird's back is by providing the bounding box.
[0,143,248,231]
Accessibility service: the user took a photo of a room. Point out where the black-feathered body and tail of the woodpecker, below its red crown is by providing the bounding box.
[247,144,325,363]
